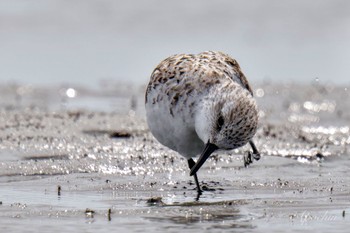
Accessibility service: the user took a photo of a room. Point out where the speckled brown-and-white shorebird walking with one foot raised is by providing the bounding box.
[145,51,260,195]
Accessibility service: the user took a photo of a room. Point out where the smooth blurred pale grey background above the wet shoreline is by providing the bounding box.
[0,0,350,87]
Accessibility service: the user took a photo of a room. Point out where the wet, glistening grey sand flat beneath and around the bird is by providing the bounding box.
[0,82,350,232]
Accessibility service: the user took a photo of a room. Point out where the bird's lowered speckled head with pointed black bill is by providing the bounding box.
[191,89,258,175]
